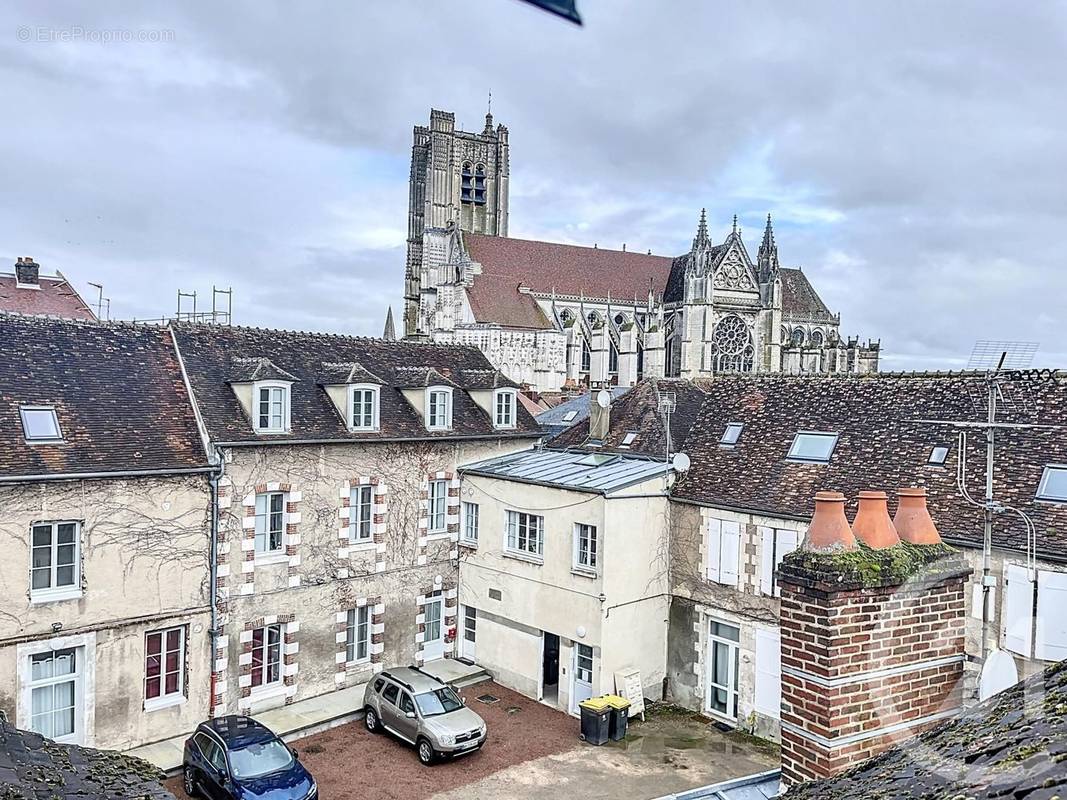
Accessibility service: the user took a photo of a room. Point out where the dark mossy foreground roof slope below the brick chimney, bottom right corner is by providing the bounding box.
[783,661,1067,800]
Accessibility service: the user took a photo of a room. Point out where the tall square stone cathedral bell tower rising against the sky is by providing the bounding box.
[403,109,508,336]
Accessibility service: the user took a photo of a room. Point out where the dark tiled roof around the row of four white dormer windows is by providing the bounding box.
[174,324,540,444]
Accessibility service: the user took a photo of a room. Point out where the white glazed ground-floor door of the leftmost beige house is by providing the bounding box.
[30,647,85,743]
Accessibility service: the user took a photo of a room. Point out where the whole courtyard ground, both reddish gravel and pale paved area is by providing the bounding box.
[168,683,777,800]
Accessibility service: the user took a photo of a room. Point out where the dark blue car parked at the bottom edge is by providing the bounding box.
[182,715,319,800]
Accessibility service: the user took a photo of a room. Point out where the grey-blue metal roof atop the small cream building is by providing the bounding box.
[461,450,669,494]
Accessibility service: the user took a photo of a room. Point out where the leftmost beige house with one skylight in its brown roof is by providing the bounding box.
[0,315,212,749]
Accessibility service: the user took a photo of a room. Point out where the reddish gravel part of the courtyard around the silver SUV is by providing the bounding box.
[166,682,579,800]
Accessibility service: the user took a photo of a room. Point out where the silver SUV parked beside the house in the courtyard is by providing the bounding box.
[363,667,489,765]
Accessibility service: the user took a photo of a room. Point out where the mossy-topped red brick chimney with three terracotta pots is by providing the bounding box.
[778,490,971,786]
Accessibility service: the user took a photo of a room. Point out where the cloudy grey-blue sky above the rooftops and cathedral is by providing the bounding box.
[0,0,1067,369]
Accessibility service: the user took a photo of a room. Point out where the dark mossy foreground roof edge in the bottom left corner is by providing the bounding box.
[0,720,174,800]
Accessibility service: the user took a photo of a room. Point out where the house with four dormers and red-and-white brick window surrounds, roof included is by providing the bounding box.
[174,325,539,715]
